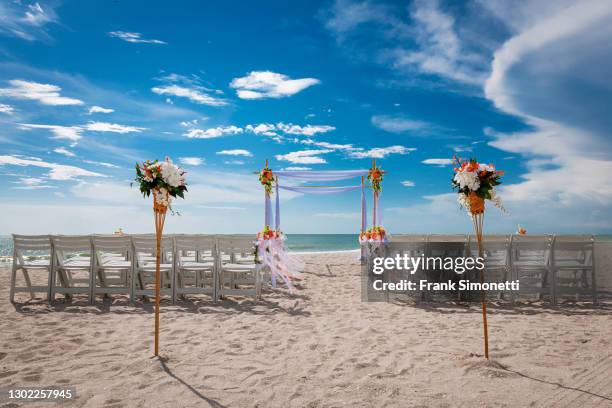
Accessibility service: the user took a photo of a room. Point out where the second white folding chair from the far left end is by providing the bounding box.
[50,235,93,302]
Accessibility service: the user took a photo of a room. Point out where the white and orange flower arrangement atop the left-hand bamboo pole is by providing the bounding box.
[134,157,187,211]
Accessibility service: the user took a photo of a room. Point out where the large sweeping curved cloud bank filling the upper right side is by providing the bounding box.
[484,1,612,220]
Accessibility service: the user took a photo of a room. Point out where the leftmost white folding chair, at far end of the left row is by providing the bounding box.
[10,234,53,302]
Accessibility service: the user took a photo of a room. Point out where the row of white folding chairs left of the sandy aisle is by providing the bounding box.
[10,234,261,302]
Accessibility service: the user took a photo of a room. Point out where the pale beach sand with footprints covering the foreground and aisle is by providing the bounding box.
[0,253,612,407]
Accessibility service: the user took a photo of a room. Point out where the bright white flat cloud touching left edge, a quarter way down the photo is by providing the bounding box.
[0,79,84,106]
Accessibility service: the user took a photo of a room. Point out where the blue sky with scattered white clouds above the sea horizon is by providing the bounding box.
[0,0,612,234]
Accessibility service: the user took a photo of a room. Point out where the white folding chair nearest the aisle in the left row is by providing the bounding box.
[217,235,262,299]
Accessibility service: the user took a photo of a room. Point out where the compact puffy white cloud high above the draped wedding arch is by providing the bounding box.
[230,71,320,99]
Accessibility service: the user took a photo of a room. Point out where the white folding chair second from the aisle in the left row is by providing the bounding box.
[174,235,217,300]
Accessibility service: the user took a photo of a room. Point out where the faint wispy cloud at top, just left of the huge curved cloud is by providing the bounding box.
[326,0,488,85]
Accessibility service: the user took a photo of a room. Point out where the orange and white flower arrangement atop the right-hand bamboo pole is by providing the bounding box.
[452,157,506,215]
